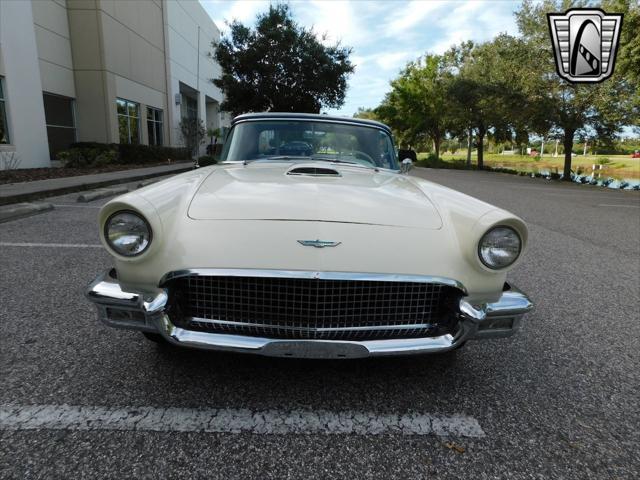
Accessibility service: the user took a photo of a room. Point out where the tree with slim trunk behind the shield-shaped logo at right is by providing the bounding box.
[515,0,637,180]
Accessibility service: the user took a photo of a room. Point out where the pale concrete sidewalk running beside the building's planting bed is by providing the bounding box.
[0,162,193,205]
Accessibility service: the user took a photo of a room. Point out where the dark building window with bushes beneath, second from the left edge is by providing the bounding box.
[42,93,76,158]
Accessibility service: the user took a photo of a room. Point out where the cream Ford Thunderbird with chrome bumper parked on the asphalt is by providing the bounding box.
[87,113,532,358]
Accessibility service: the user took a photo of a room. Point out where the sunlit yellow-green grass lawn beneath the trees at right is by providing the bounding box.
[418,152,640,180]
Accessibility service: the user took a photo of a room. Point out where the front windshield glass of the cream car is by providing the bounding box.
[222,120,399,170]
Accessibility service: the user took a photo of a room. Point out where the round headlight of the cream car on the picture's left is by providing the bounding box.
[104,211,151,257]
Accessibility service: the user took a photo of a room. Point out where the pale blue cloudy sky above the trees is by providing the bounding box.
[200,0,520,116]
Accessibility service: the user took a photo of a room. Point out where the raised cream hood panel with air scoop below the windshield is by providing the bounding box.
[188,162,442,229]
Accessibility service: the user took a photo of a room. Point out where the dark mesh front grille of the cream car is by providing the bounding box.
[169,275,461,340]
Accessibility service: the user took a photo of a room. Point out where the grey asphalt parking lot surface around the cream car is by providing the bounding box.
[0,169,640,479]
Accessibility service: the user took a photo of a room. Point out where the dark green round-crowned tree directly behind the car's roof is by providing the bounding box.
[213,4,354,115]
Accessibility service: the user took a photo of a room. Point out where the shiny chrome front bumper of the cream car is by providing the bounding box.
[86,270,533,358]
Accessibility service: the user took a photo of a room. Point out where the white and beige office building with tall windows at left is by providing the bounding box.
[0,0,227,168]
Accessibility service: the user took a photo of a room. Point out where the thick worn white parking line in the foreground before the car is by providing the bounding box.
[0,404,485,438]
